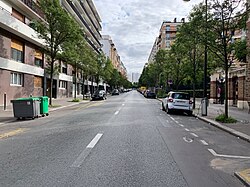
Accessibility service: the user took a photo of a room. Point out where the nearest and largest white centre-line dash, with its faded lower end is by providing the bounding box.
[71,133,103,167]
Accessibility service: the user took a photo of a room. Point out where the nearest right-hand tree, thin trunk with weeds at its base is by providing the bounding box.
[208,0,248,118]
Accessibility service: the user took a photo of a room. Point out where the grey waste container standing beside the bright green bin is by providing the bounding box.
[11,97,40,119]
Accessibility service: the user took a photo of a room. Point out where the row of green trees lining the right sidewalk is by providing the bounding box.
[139,0,249,117]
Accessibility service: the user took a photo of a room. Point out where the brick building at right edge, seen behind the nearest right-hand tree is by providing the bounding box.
[210,29,250,109]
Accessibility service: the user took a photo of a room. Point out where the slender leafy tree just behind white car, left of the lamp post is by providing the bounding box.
[175,4,209,108]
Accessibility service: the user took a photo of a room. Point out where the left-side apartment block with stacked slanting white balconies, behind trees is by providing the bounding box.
[60,0,102,95]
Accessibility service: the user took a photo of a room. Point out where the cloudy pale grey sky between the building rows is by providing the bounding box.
[93,0,202,73]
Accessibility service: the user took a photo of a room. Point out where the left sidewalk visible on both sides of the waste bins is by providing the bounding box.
[0,98,89,125]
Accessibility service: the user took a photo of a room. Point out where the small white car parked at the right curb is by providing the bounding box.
[162,91,193,115]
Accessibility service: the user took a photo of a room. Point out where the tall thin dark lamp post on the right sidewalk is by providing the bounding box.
[183,0,208,116]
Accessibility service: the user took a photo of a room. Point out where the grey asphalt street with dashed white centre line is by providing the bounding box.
[0,91,250,187]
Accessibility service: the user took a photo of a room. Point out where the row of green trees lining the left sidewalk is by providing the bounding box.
[33,0,130,105]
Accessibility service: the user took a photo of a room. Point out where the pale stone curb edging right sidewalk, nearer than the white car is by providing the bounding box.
[194,115,250,143]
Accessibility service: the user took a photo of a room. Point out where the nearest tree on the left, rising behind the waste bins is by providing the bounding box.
[34,0,80,105]
